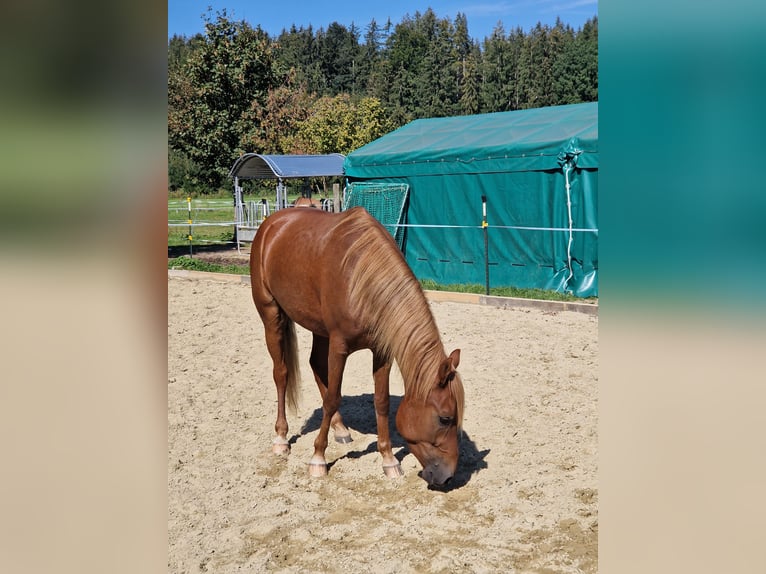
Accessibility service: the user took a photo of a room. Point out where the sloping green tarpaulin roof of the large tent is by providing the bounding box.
[344,102,598,178]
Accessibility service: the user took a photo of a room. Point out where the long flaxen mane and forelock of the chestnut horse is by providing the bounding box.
[336,209,464,426]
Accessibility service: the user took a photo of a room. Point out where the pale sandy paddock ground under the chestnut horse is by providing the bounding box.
[168,278,598,573]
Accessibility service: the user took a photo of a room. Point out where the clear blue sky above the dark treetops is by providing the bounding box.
[168,0,598,41]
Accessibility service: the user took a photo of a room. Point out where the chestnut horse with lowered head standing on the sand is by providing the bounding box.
[250,207,465,488]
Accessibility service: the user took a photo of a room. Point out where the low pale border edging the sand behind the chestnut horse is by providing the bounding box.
[168,269,598,316]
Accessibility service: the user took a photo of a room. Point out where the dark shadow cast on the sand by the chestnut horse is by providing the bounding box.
[290,393,490,491]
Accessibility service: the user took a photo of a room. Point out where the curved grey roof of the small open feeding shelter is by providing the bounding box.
[229,153,345,179]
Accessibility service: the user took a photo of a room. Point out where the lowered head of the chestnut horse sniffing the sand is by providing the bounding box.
[396,349,464,487]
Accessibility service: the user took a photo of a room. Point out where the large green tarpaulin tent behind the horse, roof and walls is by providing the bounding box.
[343,102,598,297]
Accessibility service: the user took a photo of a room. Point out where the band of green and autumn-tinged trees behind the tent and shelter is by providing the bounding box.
[168,8,598,194]
